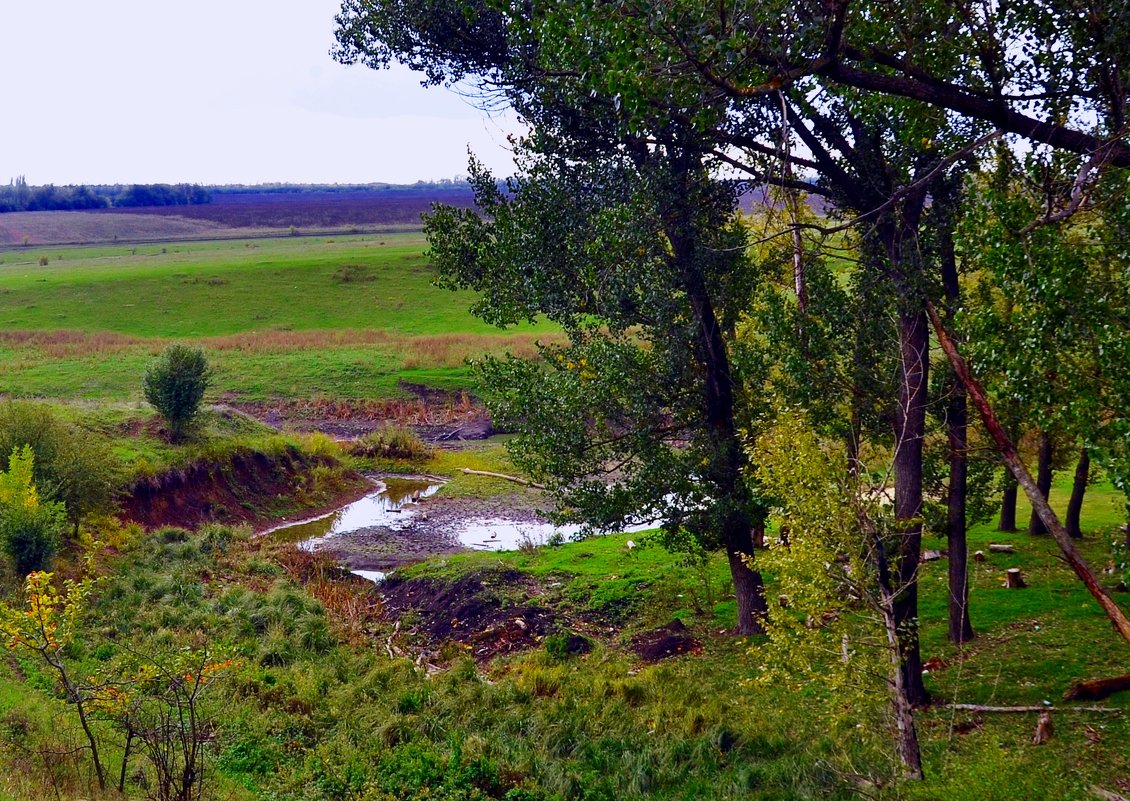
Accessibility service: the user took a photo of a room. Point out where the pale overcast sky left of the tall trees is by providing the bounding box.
[0,0,519,184]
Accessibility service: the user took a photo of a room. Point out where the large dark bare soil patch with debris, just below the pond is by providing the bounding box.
[382,571,559,660]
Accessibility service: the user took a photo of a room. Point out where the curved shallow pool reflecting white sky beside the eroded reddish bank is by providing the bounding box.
[264,478,442,550]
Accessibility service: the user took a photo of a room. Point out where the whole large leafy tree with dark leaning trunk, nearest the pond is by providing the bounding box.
[338,2,765,634]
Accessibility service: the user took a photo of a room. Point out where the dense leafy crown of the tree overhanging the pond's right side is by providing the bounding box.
[425,147,759,569]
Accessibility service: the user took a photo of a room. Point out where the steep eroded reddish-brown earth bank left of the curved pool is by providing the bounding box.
[122,446,363,528]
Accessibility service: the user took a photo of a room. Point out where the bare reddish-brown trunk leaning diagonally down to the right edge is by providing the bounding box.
[927,302,1130,642]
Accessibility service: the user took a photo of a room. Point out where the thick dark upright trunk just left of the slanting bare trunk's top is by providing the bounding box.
[893,302,930,706]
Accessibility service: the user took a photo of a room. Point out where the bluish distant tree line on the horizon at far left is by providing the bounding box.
[0,175,211,214]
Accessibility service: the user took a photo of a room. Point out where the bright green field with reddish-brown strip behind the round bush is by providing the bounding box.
[0,234,551,401]
